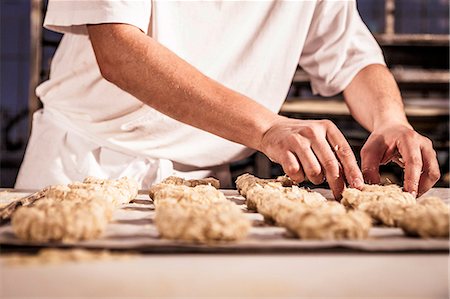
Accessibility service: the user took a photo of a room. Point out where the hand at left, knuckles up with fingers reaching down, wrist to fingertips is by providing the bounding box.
[260,116,363,198]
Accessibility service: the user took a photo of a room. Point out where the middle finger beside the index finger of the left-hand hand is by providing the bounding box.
[312,140,345,199]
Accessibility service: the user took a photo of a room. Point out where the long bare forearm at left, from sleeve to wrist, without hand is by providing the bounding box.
[88,24,278,149]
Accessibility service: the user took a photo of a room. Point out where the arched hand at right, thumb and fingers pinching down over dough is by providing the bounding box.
[361,123,440,196]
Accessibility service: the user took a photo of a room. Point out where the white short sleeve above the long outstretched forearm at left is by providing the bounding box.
[44,0,151,34]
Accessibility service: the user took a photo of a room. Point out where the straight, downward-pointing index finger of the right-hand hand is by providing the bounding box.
[397,138,423,196]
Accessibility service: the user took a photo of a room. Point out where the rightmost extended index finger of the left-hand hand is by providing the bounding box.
[327,125,364,188]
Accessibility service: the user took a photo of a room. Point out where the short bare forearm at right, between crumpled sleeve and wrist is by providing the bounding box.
[344,64,409,132]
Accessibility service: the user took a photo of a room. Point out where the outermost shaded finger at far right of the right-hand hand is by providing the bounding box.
[418,142,441,196]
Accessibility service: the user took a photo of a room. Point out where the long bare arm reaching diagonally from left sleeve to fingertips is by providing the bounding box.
[88,24,362,197]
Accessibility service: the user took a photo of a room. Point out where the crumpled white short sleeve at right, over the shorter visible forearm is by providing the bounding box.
[299,0,385,96]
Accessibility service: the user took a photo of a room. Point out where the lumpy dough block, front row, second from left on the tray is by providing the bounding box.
[155,199,251,243]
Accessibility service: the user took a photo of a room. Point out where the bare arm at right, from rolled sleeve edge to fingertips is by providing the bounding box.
[344,65,440,195]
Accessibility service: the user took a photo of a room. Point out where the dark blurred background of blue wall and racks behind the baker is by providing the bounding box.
[0,0,450,187]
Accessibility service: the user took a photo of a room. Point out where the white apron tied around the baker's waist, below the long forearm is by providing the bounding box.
[15,109,231,189]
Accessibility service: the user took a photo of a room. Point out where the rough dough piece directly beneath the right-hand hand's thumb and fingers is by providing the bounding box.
[341,185,416,208]
